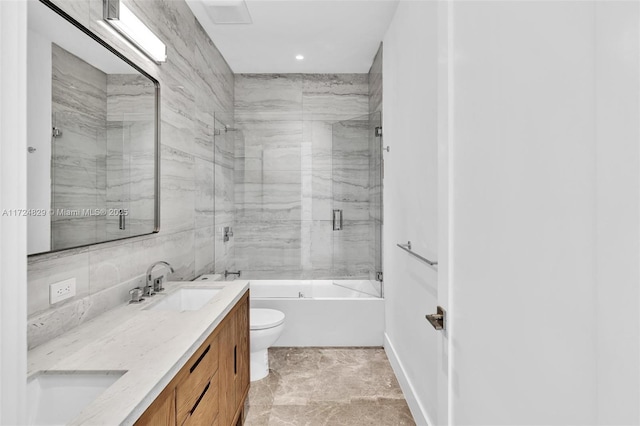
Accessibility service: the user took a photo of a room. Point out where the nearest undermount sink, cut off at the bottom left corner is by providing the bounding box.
[27,371,125,425]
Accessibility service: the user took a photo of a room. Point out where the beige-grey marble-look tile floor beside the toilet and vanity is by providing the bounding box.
[245,348,415,426]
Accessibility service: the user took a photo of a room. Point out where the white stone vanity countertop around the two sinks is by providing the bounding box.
[28,280,249,425]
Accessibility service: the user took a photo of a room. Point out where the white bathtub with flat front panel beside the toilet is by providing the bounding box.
[249,280,384,346]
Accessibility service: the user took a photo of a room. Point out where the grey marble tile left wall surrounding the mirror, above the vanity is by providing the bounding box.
[28,0,235,347]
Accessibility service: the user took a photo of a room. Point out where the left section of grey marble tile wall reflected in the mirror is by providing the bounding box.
[51,44,107,250]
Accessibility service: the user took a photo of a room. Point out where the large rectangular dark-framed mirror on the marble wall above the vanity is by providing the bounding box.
[25,1,159,254]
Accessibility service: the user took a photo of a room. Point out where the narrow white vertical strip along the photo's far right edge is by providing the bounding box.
[595,2,640,425]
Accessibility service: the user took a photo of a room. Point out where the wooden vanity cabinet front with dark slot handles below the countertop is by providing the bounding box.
[136,291,249,426]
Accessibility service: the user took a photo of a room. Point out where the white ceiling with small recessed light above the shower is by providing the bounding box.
[182,0,398,74]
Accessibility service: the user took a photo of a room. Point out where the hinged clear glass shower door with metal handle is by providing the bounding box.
[332,113,382,297]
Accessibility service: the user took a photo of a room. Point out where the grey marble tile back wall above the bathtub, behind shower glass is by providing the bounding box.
[234,74,372,279]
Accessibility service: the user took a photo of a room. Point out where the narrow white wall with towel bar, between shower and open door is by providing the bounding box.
[383,1,446,425]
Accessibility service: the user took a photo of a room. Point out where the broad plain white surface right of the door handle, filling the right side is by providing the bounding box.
[449,2,639,425]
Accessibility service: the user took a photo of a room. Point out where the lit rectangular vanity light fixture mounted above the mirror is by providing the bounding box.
[103,0,167,64]
